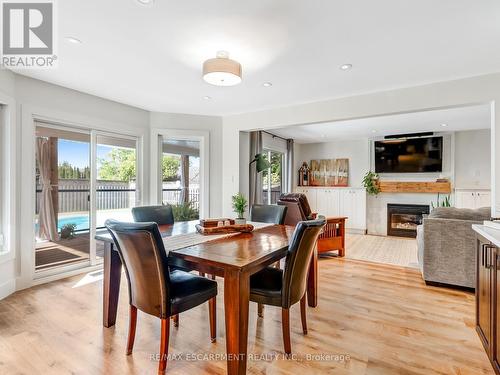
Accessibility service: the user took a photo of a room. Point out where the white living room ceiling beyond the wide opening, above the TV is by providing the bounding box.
[271,105,491,143]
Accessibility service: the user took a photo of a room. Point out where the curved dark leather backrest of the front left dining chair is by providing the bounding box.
[105,220,170,318]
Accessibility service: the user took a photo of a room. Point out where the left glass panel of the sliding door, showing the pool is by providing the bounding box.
[34,124,91,271]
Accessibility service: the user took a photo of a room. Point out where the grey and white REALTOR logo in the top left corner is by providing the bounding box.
[1,0,57,69]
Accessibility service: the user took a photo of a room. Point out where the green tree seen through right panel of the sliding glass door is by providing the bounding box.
[98,148,136,181]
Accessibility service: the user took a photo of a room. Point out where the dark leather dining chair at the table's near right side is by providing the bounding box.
[250,217,326,355]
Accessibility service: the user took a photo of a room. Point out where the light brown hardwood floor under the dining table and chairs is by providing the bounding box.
[0,258,493,375]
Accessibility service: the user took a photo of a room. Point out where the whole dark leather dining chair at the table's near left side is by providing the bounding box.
[105,220,217,374]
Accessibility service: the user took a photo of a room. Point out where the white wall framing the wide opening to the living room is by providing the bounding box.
[222,73,500,215]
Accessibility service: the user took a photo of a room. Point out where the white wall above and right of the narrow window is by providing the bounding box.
[150,112,223,217]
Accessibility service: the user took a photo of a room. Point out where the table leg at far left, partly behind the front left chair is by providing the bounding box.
[102,242,122,328]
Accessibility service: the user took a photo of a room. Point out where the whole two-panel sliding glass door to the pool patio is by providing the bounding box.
[35,123,140,274]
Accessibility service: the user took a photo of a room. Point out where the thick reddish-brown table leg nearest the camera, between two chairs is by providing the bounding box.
[224,270,250,375]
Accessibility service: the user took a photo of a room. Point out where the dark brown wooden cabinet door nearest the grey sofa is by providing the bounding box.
[476,240,493,353]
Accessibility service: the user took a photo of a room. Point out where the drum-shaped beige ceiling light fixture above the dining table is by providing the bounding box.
[203,51,241,86]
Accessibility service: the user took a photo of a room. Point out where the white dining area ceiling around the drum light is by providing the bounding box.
[14,0,500,115]
